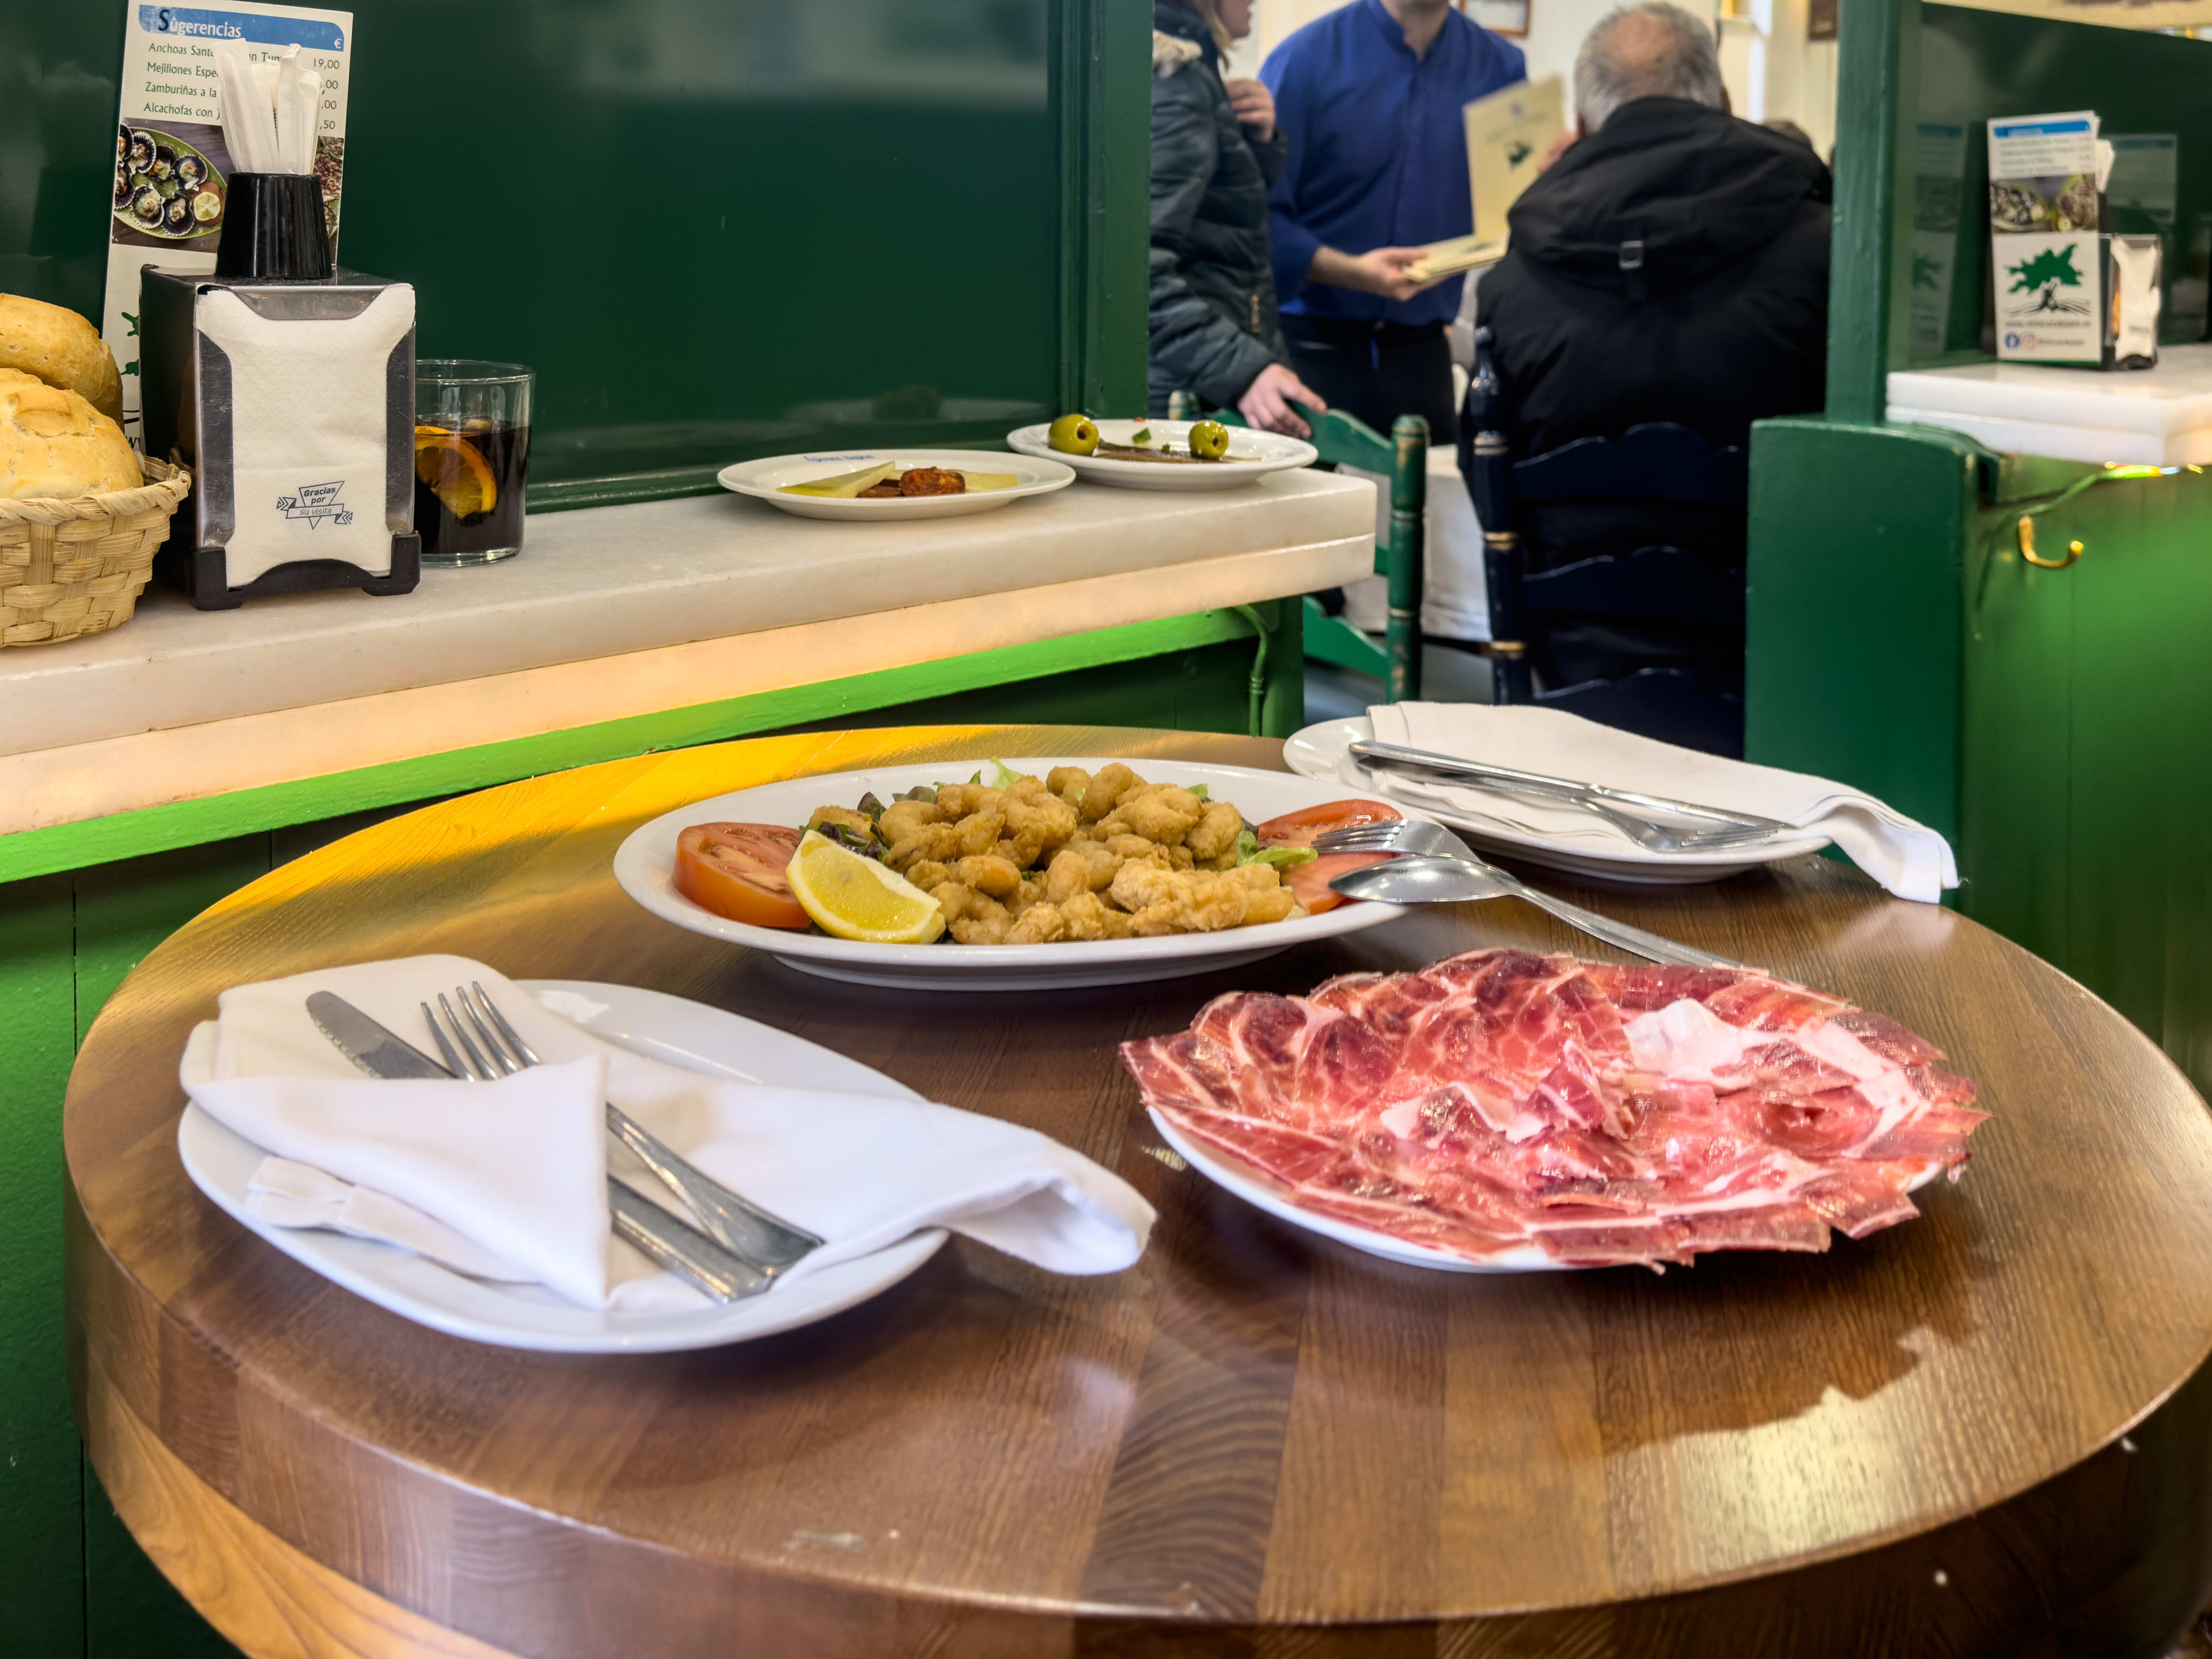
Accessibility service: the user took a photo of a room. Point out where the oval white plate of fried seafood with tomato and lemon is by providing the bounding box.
[615,756,1404,991]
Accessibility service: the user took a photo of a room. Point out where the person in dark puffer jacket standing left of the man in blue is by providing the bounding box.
[1146,0,1327,438]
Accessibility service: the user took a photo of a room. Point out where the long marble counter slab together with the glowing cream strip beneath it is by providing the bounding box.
[0,471,1376,834]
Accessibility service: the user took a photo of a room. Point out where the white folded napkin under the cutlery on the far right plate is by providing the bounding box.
[1338,703,1957,905]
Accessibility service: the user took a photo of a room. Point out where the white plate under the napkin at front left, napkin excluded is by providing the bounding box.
[177,980,945,1354]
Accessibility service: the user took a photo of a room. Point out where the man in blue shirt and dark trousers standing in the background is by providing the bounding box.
[1259,0,1527,442]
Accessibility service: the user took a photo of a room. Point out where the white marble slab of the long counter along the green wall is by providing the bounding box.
[0,471,1374,754]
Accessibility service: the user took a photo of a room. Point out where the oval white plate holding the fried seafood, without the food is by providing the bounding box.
[615,754,1404,991]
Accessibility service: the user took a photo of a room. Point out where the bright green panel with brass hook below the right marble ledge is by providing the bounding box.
[1960,463,2212,1070]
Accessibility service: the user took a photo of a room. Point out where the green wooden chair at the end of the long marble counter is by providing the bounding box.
[1203,394,1429,703]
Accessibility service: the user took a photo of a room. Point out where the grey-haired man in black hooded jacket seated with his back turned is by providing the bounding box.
[1478,2,1832,458]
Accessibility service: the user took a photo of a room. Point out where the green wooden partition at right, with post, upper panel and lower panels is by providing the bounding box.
[1745,0,2212,1111]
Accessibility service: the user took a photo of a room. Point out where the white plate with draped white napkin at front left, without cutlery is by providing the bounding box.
[177,956,1153,1354]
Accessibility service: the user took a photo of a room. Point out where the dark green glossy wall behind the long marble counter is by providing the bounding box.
[0,0,1150,505]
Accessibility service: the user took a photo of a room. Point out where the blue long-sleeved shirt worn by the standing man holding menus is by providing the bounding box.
[1259,0,1528,325]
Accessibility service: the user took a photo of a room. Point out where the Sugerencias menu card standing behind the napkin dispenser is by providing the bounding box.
[102,0,354,435]
